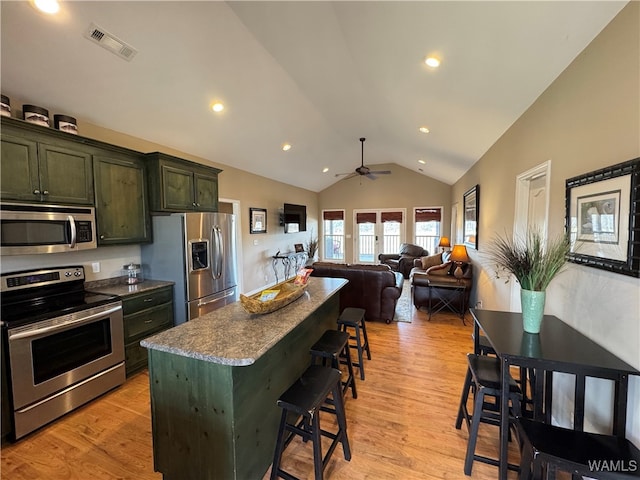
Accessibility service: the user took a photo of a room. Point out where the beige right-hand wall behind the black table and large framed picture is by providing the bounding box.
[452,2,640,445]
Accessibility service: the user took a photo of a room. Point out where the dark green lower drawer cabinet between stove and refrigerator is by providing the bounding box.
[121,286,173,376]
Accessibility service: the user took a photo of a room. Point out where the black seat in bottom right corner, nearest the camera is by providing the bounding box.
[518,418,640,480]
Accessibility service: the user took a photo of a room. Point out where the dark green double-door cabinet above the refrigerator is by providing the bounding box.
[146,152,222,212]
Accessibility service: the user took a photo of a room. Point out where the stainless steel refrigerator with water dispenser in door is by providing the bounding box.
[141,213,239,325]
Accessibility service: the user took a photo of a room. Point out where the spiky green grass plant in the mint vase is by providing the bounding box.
[486,229,570,292]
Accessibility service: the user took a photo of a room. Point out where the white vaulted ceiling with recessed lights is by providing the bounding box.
[1,1,627,191]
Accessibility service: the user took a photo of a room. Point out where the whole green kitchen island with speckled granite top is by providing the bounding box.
[141,277,347,480]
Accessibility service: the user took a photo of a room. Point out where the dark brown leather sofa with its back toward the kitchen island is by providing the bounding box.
[311,262,404,323]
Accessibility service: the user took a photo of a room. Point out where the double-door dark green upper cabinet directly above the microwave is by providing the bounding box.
[0,118,94,205]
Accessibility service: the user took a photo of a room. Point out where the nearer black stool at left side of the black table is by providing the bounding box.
[456,353,522,475]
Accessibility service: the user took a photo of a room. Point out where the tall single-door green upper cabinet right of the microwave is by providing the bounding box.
[93,151,151,245]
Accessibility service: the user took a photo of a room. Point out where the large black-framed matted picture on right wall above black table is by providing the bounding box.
[565,158,640,277]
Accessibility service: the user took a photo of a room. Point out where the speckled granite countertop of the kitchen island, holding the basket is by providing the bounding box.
[140,277,347,366]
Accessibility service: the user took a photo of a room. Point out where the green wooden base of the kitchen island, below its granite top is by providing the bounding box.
[149,293,339,480]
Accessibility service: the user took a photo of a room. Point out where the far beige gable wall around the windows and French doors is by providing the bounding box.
[318,164,451,263]
